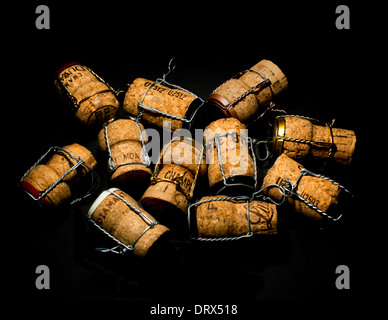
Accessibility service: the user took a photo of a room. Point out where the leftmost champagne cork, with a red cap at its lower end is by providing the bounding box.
[20,143,97,207]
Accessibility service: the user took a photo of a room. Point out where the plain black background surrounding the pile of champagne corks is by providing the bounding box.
[2,1,382,314]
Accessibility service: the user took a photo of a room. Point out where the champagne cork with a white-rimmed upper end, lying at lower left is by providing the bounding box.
[88,188,169,257]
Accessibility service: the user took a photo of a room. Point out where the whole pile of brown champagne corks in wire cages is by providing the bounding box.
[19,60,356,256]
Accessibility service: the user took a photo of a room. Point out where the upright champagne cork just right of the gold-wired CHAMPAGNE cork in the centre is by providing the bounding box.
[204,118,255,191]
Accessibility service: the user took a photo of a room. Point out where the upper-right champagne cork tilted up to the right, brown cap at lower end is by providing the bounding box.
[208,59,288,122]
